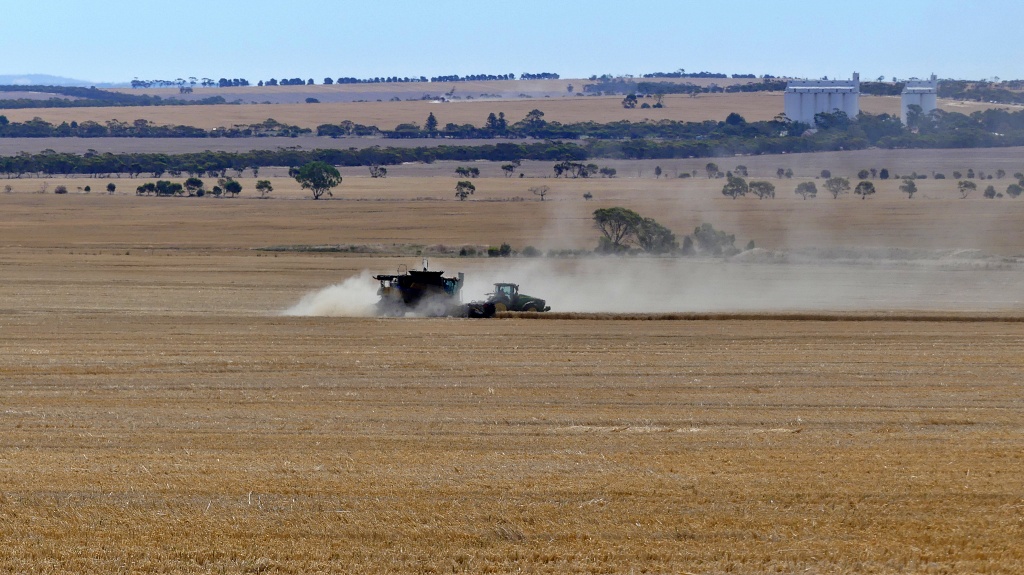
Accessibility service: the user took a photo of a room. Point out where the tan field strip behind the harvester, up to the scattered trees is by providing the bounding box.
[6,166,1024,256]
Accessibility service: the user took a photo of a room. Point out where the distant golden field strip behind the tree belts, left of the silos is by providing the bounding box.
[0,93,1009,129]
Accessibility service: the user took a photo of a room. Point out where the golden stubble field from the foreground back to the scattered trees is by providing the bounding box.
[0,171,1024,573]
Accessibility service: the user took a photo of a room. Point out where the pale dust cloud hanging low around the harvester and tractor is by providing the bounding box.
[285,251,1024,316]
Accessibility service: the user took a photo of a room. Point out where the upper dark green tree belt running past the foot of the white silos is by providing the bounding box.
[9,100,1024,164]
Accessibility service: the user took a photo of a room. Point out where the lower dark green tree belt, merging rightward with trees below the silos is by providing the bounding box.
[9,109,1024,177]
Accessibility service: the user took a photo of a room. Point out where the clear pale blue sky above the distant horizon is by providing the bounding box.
[0,0,1024,83]
